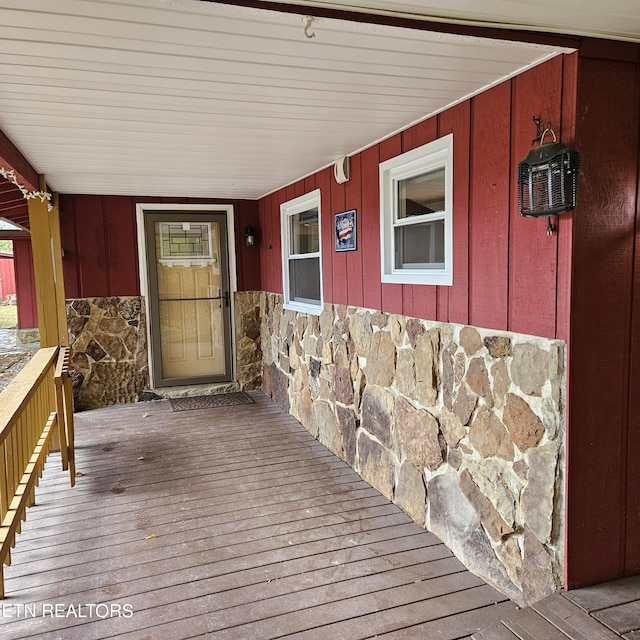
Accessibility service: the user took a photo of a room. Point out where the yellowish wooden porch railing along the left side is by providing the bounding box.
[0,347,75,598]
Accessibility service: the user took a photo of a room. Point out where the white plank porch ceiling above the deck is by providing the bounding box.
[0,0,639,198]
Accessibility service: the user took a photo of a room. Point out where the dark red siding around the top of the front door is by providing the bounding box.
[60,195,260,298]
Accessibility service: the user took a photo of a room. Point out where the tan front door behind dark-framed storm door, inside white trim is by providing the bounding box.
[145,211,232,387]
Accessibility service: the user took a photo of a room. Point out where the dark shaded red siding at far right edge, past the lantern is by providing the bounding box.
[566,45,640,587]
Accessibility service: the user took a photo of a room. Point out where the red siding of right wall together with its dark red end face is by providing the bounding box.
[259,46,640,588]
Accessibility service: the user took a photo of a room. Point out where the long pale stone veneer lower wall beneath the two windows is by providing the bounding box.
[255,293,565,604]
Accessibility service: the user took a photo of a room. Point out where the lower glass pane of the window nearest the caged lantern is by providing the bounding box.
[394,220,445,269]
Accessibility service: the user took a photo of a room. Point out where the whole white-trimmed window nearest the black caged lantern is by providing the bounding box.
[380,134,453,285]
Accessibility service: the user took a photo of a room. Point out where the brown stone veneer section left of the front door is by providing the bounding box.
[67,296,149,411]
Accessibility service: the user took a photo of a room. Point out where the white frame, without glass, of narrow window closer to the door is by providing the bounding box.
[280,189,324,316]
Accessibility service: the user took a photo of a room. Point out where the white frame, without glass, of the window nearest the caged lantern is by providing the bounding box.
[380,133,453,286]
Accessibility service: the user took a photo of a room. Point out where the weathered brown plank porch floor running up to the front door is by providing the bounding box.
[0,392,516,640]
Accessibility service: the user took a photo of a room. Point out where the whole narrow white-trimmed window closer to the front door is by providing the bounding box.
[280,189,322,315]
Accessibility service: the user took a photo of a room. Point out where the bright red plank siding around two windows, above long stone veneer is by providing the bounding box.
[259,56,576,338]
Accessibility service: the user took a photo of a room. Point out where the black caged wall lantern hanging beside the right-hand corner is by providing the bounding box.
[518,119,580,218]
